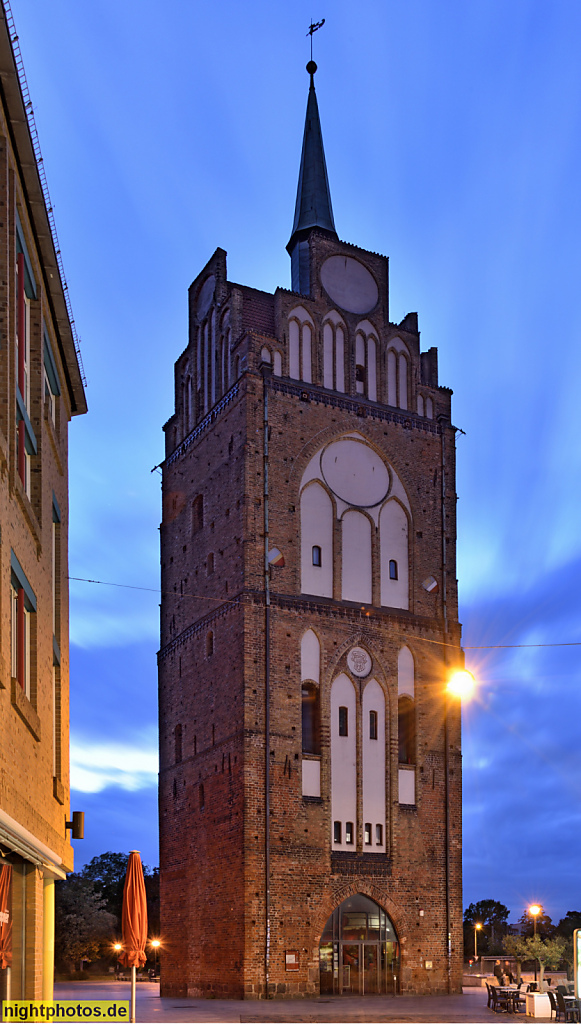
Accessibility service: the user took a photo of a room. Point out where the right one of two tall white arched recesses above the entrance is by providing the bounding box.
[362,679,385,853]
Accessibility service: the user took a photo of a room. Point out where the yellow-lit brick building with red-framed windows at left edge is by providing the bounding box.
[0,7,86,999]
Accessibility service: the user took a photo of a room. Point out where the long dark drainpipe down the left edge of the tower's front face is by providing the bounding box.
[260,362,273,999]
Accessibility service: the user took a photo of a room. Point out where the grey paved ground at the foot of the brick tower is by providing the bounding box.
[54,982,549,1024]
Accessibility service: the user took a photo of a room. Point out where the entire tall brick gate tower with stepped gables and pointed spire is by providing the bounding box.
[159,62,462,998]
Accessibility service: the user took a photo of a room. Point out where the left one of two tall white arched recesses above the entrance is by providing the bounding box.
[331,673,357,850]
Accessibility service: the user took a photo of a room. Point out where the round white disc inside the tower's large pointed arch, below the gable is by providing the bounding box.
[321,437,389,508]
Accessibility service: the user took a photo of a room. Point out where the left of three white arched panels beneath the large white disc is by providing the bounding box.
[300,483,333,597]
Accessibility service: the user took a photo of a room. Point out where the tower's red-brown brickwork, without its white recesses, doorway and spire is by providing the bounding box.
[159,224,462,997]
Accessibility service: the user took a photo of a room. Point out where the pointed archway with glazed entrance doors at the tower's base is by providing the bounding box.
[319,893,400,995]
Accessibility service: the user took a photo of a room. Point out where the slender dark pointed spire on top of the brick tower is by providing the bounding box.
[287,60,337,274]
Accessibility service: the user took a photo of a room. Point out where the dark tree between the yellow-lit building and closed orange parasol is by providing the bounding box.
[54,874,116,970]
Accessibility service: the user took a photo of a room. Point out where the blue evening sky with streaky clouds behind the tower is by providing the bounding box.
[11,0,581,920]
